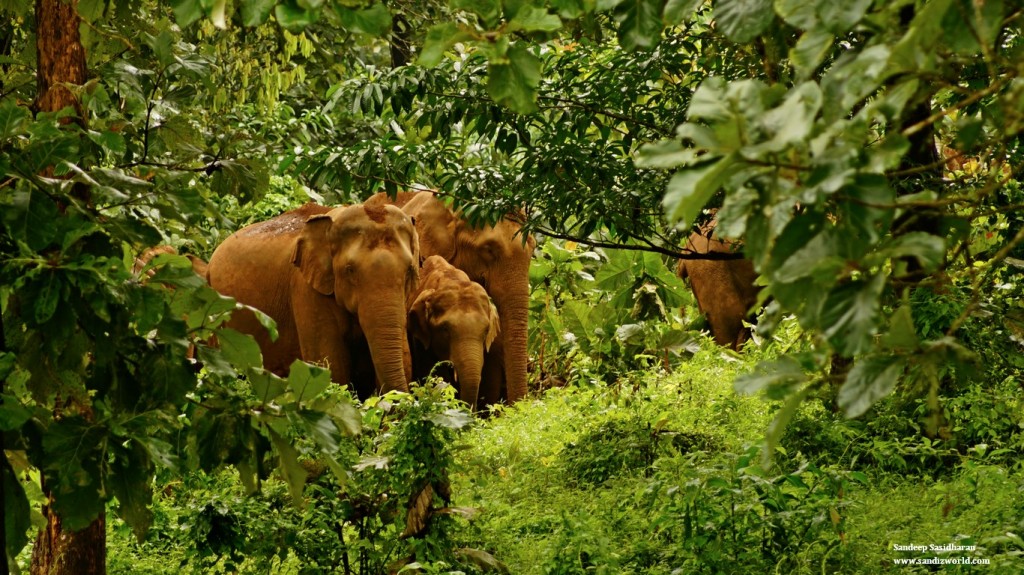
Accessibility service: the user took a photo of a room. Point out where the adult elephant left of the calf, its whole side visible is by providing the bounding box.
[207,204,420,396]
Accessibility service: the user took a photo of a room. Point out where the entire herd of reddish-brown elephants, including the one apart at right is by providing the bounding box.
[146,191,758,409]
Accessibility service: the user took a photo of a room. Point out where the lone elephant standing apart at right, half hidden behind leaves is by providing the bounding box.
[676,214,761,351]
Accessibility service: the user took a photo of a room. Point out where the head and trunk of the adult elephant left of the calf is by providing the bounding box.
[291,205,420,392]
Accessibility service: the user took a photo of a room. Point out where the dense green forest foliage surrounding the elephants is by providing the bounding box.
[6,0,1024,573]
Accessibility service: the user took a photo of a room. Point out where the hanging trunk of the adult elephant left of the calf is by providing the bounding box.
[358,294,412,393]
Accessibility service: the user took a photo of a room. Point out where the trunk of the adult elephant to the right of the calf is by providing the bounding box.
[493,258,529,404]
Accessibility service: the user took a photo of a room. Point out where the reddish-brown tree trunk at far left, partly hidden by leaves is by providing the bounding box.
[30,0,106,575]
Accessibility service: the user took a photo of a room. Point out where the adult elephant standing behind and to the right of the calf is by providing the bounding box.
[367,191,537,405]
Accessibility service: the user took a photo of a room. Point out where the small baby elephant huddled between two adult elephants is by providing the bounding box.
[409,256,501,410]
